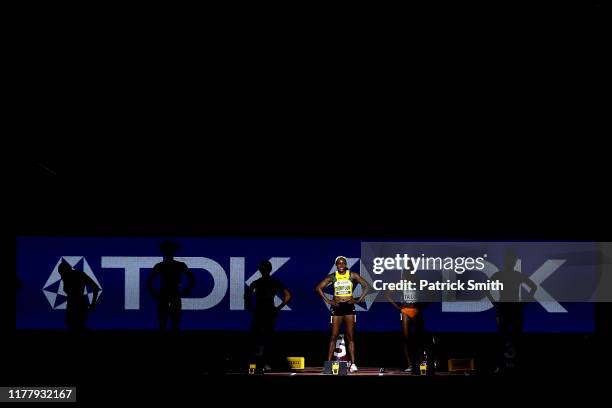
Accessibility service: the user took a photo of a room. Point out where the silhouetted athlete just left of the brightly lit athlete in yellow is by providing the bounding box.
[244,261,291,369]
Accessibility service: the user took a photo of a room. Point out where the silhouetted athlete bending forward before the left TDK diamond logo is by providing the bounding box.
[58,260,100,331]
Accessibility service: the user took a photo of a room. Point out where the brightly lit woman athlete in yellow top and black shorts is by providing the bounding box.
[316,256,370,372]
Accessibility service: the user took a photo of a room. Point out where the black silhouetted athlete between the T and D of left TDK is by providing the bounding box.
[147,241,195,331]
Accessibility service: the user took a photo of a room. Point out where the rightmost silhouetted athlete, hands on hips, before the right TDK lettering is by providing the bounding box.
[487,250,538,371]
